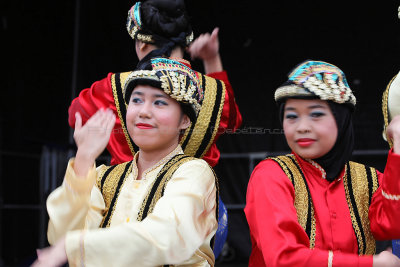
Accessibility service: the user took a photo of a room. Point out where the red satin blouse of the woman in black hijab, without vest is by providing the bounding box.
[245,151,400,267]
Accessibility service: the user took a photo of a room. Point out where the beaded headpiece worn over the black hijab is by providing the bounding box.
[275,60,356,106]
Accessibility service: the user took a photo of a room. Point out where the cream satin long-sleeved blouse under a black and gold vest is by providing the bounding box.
[47,146,218,267]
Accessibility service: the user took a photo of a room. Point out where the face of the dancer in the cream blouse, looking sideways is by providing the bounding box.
[126,85,190,151]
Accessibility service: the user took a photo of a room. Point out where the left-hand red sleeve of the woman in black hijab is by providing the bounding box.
[245,160,372,267]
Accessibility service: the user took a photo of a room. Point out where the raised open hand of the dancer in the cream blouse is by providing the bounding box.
[74,109,116,176]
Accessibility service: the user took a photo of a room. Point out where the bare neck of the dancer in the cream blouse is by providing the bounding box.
[137,143,178,179]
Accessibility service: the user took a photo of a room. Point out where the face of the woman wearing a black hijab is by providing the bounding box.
[283,99,338,159]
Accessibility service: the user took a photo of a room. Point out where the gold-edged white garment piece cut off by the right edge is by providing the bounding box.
[382,72,400,147]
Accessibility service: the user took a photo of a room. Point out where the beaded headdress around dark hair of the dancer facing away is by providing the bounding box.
[126,2,194,45]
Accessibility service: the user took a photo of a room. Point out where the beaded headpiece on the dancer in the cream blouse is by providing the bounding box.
[124,58,204,115]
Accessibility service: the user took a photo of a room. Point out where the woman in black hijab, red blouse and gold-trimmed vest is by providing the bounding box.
[245,61,400,267]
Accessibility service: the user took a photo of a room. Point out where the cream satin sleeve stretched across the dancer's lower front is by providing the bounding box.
[66,160,218,267]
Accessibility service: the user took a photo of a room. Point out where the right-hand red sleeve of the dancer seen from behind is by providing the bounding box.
[203,71,242,167]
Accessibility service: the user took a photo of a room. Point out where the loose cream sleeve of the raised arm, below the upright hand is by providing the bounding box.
[46,159,105,244]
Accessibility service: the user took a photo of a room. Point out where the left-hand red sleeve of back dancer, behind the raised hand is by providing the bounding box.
[68,73,117,128]
